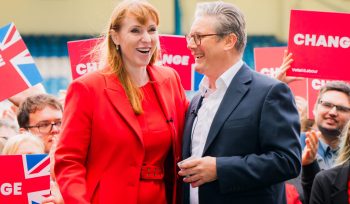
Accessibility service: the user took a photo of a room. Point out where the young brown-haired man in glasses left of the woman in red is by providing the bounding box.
[17,94,63,204]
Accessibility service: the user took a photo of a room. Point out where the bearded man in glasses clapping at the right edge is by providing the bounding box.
[301,81,350,203]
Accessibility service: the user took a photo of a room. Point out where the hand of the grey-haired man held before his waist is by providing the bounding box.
[179,156,217,188]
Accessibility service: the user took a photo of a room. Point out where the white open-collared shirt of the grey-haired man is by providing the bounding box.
[190,60,243,204]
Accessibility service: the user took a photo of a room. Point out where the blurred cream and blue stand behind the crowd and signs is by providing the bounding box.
[0,0,350,95]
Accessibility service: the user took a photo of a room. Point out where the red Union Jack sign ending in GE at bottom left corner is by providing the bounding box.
[0,154,50,204]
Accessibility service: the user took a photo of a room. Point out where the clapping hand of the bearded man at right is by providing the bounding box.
[301,130,321,166]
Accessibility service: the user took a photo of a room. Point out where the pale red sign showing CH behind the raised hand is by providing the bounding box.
[254,47,307,99]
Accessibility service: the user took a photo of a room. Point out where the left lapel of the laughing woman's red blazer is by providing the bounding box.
[105,74,143,144]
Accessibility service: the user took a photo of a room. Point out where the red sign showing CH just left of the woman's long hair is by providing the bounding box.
[67,38,102,80]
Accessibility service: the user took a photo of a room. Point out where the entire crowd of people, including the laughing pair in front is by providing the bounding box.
[0,0,350,204]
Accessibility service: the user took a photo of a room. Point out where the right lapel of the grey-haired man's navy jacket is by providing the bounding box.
[203,65,252,155]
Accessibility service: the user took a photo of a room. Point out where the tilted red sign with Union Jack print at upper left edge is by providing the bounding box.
[0,23,42,101]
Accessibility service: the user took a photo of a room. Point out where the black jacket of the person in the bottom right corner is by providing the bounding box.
[310,162,350,204]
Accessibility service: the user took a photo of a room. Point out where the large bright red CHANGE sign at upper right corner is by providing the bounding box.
[287,10,350,80]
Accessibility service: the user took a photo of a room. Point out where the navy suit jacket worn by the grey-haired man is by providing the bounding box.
[183,65,301,204]
